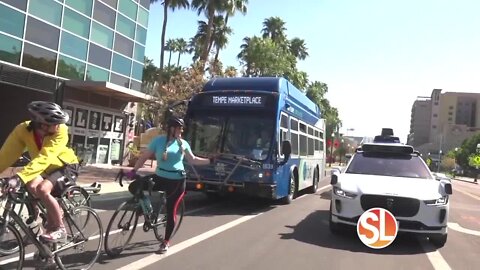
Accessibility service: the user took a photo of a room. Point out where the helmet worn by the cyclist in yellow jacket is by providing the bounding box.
[28,101,70,125]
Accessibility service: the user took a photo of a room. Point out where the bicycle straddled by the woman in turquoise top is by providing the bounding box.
[105,170,185,258]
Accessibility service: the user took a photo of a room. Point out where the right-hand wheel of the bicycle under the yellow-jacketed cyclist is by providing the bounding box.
[54,206,104,270]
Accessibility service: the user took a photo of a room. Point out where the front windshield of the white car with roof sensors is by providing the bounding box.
[345,153,432,179]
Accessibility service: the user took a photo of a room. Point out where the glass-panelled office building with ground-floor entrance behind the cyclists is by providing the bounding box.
[0,0,150,163]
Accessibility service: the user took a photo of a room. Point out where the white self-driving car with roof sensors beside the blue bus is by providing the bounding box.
[330,133,452,247]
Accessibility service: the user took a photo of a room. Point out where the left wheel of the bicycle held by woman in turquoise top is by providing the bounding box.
[105,201,139,257]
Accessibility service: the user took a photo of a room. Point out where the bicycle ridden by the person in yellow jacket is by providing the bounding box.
[0,178,104,269]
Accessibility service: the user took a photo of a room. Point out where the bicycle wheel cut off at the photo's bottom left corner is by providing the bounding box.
[0,221,25,270]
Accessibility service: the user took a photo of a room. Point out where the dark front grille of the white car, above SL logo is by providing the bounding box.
[360,195,420,217]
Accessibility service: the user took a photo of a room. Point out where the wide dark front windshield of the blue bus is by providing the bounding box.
[186,114,274,160]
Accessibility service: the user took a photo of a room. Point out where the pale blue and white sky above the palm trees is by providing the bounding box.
[145,0,480,142]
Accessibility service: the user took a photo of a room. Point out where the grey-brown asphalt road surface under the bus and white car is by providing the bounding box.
[3,178,480,270]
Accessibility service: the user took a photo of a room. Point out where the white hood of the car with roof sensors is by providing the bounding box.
[338,174,445,200]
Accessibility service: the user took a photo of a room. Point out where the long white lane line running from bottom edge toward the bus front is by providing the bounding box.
[117,212,264,270]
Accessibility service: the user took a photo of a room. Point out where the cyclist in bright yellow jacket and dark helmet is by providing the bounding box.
[0,101,78,242]
